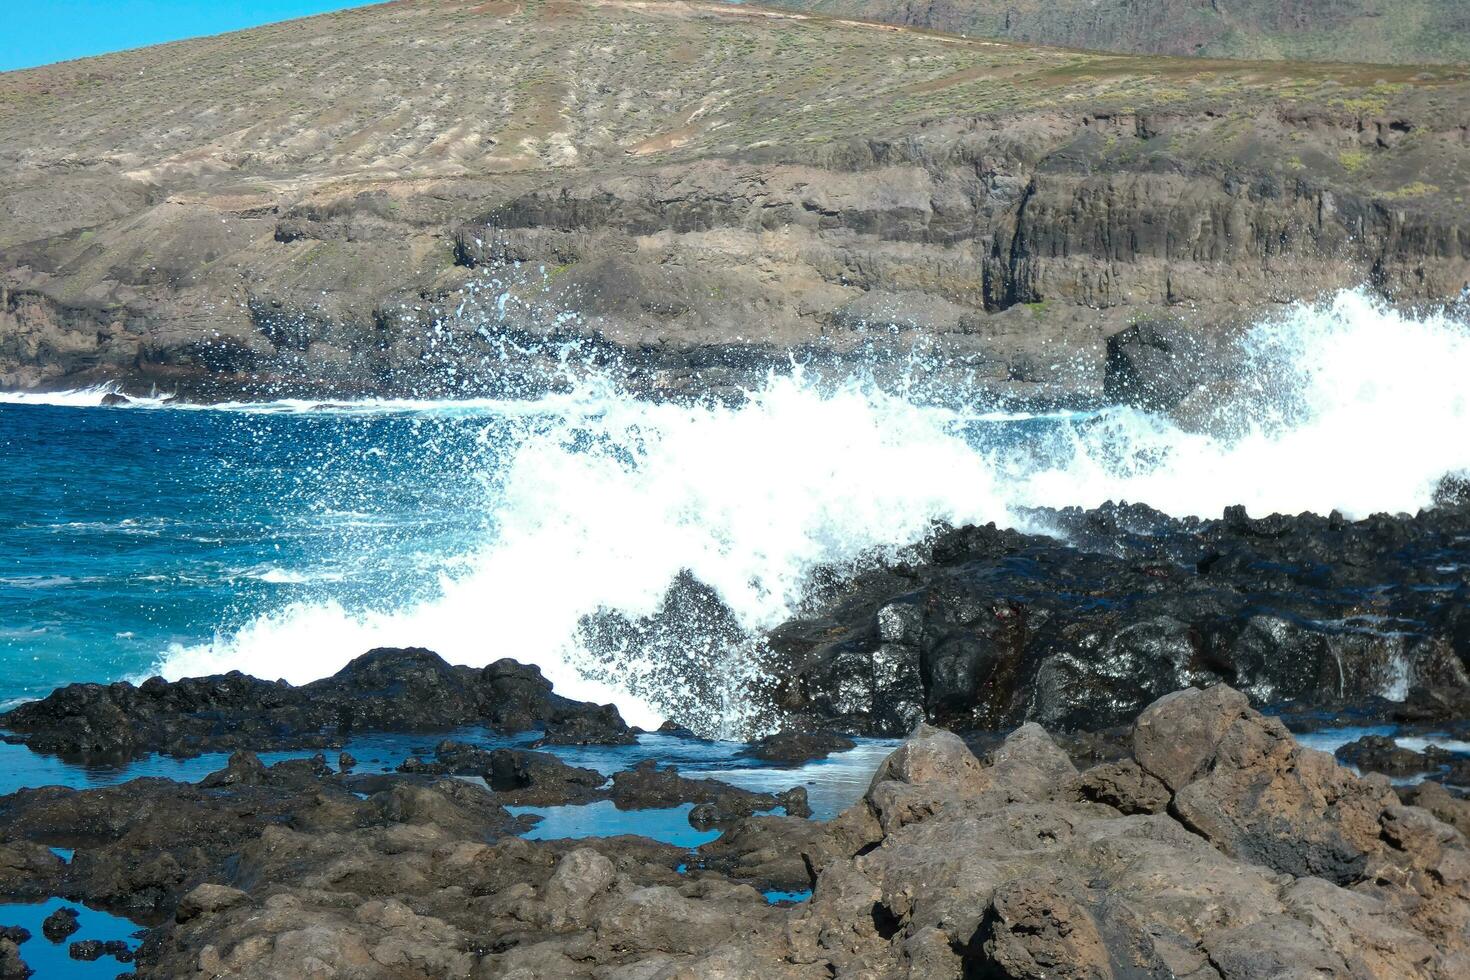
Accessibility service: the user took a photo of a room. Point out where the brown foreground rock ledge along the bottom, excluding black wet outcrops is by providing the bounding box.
[0,685,1470,980]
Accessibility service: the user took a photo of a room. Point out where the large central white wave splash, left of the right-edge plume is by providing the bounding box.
[163,375,1005,724]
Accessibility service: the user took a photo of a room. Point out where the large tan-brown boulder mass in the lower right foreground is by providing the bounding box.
[788,688,1470,980]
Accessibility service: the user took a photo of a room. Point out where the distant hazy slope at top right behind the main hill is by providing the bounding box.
[775,0,1470,65]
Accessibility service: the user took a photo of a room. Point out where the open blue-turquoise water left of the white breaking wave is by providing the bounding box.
[0,404,495,704]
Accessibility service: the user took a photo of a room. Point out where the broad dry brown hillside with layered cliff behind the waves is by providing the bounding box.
[0,0,1470,397]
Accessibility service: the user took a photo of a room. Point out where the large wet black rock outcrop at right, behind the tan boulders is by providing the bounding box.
[769,505,1470,735]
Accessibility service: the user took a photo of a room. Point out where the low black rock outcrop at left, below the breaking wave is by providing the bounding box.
[0,649,634,758]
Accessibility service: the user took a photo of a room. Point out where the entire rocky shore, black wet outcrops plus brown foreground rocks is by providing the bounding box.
[0,499,1470,980]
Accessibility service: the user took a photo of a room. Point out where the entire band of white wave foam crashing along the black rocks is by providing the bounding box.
[152,292,1470,726]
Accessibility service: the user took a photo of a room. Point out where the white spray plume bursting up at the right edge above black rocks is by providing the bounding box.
[1023,292,1470,517]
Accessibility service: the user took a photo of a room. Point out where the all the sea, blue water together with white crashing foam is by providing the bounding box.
[0,292,1470,736]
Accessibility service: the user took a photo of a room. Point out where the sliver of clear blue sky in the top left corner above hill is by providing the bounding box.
[0,0,388,72]
